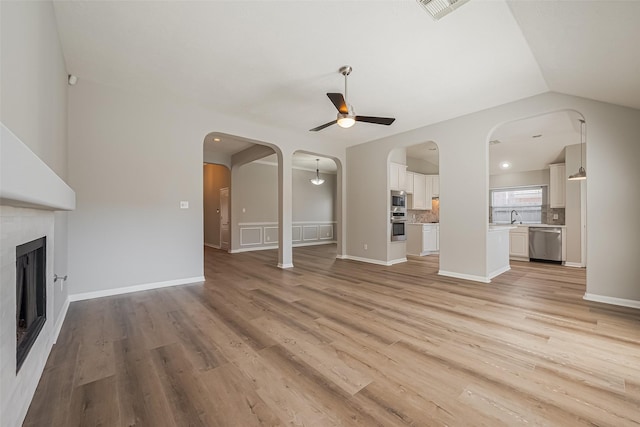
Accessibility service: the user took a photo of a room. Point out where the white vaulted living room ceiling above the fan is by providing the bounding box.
[54,0,640,146]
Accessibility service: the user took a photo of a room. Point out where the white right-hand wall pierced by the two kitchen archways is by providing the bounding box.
[347,93,640,302]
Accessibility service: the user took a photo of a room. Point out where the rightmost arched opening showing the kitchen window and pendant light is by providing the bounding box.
[488,110,587,267]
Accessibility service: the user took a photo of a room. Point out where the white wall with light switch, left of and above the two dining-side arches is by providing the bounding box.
[69,79,344,298]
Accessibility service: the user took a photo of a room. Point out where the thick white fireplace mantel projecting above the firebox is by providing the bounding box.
[0,123,76,211]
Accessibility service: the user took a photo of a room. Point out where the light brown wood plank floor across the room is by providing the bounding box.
[25,245,640,427]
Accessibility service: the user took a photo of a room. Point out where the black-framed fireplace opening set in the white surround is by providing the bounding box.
[16,237,47,372]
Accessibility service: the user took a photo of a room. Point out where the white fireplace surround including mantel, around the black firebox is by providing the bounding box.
[0,123,75,426]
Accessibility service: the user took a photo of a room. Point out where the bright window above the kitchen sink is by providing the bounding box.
[491,186,547,224]
